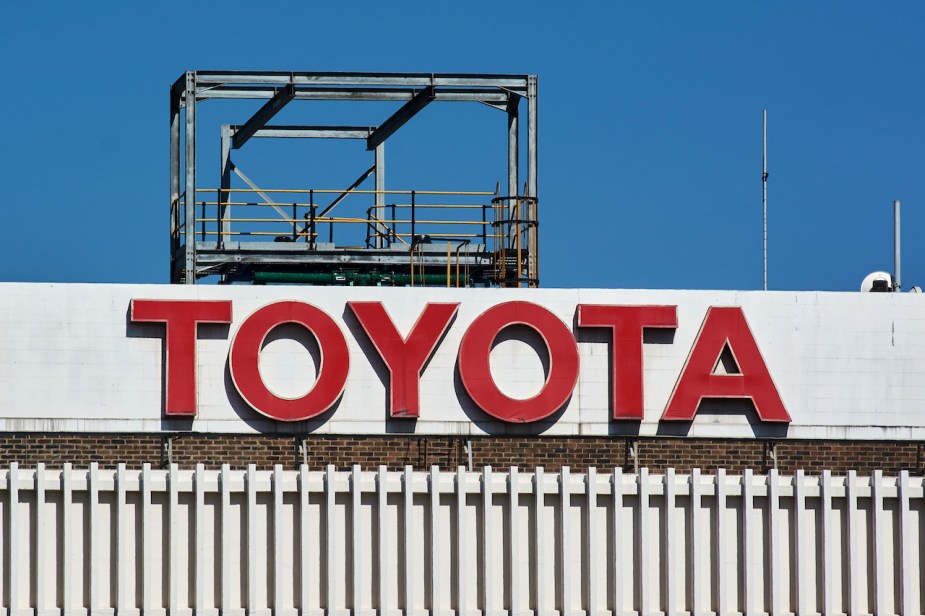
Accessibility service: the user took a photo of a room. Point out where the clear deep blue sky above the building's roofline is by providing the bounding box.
[0,1,925,291]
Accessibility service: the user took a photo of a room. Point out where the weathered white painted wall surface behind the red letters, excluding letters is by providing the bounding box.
[0,284,925,440]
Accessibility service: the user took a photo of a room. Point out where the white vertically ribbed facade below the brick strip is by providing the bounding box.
[0,465,925,616]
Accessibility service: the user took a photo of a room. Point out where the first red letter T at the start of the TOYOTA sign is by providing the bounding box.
[129,299,231,417]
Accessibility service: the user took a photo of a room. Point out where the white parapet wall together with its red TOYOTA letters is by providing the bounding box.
[0,283,925,441]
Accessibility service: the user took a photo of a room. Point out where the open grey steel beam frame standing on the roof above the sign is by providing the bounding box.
[170,71,539,286]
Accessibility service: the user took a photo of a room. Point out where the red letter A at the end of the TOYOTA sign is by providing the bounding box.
[662,307,790,422]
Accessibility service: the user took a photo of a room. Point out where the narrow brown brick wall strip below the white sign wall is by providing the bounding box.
[0,433,925,474]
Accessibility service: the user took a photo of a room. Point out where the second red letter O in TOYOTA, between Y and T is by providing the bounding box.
[459,302,578,423]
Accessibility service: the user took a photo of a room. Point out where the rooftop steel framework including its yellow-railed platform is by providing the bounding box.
[170,71,539,286]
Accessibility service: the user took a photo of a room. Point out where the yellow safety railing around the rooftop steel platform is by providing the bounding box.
[179,188,538,286]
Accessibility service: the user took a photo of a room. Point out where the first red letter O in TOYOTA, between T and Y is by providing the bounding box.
[228,302,350,421]
